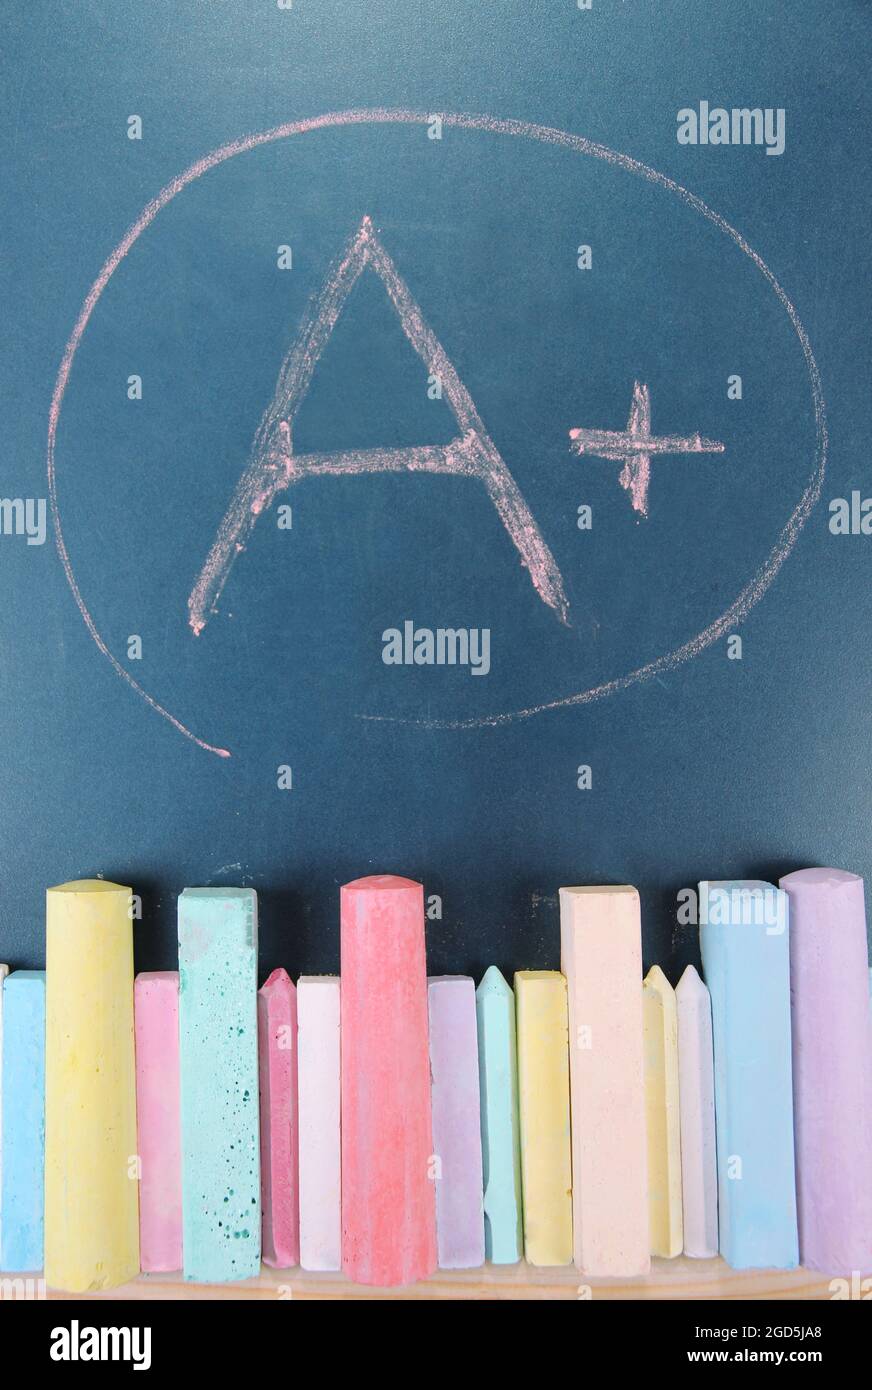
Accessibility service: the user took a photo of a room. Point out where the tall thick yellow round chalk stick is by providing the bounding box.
[45,878,139,1293]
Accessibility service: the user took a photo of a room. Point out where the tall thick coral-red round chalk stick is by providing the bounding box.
[341,874,437,1287]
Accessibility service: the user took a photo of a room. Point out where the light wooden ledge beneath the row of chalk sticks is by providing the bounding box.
[47,1258,851,1301]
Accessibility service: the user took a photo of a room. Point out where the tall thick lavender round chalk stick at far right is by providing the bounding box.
[780,869,872,1275]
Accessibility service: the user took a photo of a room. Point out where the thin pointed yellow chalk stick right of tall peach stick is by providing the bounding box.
[643,965,684,1259]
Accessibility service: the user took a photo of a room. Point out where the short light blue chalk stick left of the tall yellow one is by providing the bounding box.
[0,970,46,1272]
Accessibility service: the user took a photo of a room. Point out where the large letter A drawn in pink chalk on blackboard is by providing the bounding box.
[188,217,569,635]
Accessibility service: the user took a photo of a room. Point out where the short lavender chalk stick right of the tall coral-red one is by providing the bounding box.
[427,974,484,1269]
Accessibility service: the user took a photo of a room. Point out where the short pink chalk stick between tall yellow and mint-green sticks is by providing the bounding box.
[134,970,182,1275]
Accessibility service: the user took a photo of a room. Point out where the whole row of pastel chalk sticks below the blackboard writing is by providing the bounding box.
[0,869,872,1293]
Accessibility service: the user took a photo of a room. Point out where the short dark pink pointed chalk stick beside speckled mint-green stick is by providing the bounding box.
[257,970,300,1269]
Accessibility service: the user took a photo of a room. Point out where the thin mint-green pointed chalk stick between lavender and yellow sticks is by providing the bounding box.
[476,965,524,1265]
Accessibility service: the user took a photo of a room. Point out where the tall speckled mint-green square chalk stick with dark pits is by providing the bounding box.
[178,888,260,1283]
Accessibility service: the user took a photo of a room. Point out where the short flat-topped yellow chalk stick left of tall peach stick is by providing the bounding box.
[515,970,572,1265]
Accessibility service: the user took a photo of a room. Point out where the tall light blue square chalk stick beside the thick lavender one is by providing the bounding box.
[700,880,800,1269]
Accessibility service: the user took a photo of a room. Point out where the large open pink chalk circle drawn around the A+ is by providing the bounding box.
[46,108,827,758]
